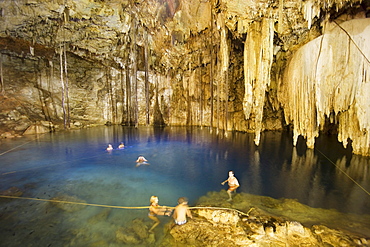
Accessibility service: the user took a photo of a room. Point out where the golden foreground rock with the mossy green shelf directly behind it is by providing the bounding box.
[166,192,368,246]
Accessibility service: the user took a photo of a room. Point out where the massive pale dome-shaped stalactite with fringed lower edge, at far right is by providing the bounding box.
[278,19,370,155]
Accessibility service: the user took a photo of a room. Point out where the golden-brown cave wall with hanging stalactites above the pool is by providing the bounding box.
[0,0,370,155]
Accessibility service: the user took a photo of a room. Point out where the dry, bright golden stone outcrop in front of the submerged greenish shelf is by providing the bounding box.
[170,210,368,247]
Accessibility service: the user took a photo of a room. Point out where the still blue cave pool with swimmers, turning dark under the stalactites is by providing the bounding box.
[0,126,370,246]
